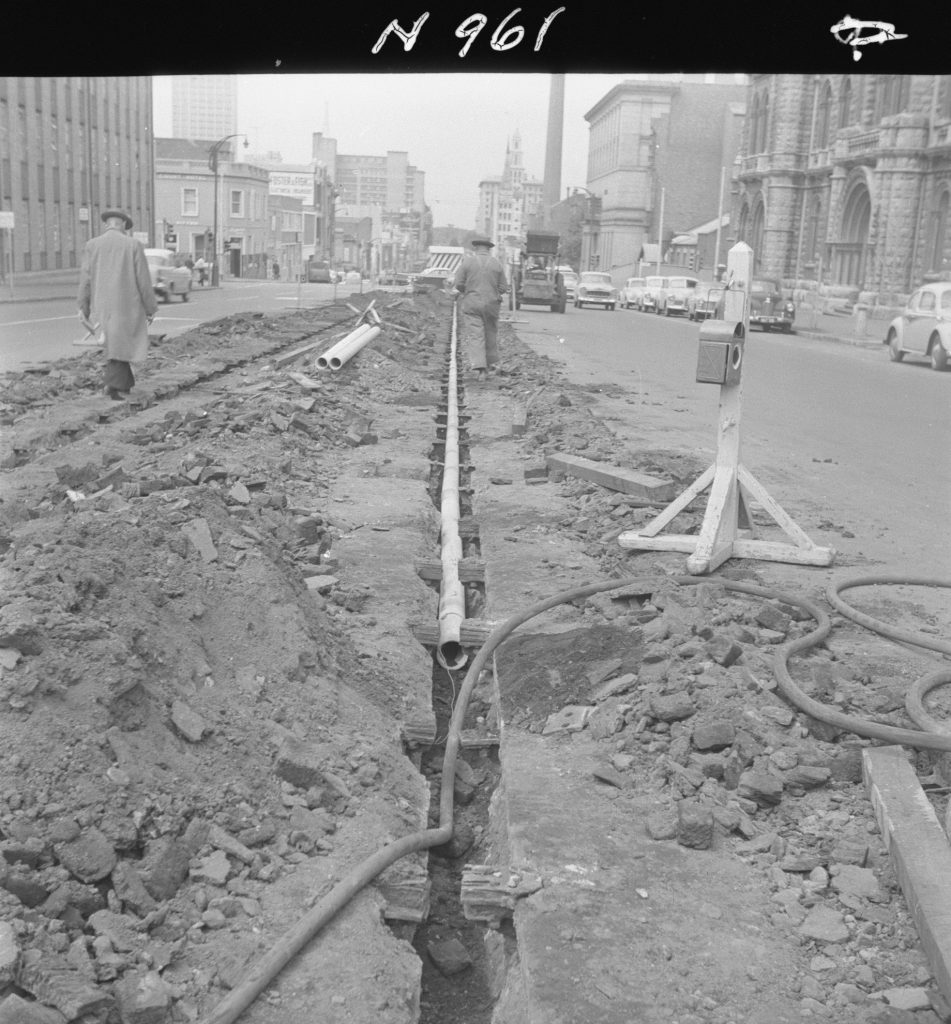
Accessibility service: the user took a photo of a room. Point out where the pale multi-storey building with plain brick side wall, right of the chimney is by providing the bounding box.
[583,76,746,282]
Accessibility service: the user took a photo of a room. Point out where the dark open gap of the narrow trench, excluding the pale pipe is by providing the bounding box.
[414,311,501,1024]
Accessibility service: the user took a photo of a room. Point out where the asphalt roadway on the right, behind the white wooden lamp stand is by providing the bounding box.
[506,299,951,577]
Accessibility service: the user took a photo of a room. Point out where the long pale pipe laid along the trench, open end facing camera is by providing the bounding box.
[436,305,466,669]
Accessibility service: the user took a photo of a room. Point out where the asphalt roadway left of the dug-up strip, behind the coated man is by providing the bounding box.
[0,281,378,373]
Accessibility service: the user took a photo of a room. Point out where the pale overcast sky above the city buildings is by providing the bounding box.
[153,73,749,228]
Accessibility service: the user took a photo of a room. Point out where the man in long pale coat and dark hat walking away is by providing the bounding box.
[79,210,159,400]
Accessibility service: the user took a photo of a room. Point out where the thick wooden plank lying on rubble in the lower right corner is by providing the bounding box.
[862,746,951,1000]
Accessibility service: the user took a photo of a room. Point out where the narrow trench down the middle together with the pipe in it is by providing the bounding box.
[414,309,504,1024]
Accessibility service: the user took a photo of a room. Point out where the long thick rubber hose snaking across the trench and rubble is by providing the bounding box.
[205,575,951,1024]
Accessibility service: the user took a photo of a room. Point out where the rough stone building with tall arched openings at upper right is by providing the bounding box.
[730,75,951,305]
